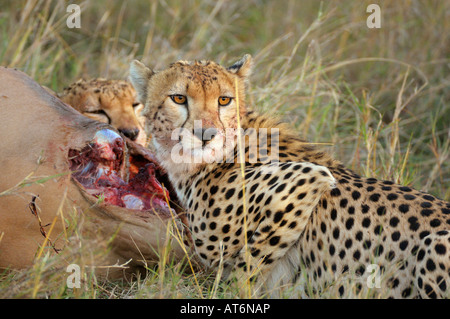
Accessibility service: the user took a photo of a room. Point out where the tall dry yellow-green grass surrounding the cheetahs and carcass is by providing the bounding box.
[0,0,450,298]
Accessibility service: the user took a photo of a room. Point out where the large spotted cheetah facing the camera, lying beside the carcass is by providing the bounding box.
[130,55,450,298]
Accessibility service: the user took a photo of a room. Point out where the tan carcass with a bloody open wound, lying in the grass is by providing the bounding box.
[0,67,192,278]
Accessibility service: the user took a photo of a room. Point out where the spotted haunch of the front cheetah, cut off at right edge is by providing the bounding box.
[415,231,450,298]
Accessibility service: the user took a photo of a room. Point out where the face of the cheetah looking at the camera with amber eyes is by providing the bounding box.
[130,55,251,173]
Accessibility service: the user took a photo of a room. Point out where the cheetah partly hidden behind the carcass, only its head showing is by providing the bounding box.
[57,78,147,146]
